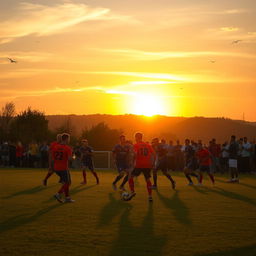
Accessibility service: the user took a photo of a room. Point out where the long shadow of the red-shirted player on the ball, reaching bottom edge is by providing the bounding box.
[109,204,167,256]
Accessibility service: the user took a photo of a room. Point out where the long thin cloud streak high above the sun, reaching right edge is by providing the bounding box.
[99,49,256,61]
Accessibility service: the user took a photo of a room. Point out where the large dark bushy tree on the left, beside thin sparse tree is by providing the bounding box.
[10,107,49,143]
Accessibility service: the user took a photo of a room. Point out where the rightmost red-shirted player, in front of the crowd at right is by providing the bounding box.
[196,143,215,185]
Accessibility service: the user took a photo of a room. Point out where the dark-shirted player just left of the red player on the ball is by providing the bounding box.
[112,135,128,190]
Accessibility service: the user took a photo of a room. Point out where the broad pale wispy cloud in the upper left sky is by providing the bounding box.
[0,2,132,44]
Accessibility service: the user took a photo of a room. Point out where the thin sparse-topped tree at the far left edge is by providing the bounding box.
[0,102,15,140]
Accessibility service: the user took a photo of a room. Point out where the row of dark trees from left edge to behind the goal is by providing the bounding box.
[0,102,122,150]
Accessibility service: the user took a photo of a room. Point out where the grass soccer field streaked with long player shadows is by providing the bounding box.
[0,169,256,256]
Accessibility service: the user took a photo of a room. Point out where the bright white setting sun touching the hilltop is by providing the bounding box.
[131,94,167,116]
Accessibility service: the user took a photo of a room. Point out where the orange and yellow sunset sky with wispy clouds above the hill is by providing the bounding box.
[0,0,256,121]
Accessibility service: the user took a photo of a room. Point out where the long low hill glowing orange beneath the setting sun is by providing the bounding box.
[47,114,256,142]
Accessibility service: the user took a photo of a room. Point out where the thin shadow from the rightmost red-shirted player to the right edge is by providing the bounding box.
[194,187,256,206]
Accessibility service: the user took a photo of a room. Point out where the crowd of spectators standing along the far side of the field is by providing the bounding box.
[0,137,256,173]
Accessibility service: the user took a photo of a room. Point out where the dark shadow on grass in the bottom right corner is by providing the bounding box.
[194,244,256,256]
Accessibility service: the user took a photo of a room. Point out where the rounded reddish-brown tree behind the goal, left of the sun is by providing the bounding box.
[81,122,123,150]
